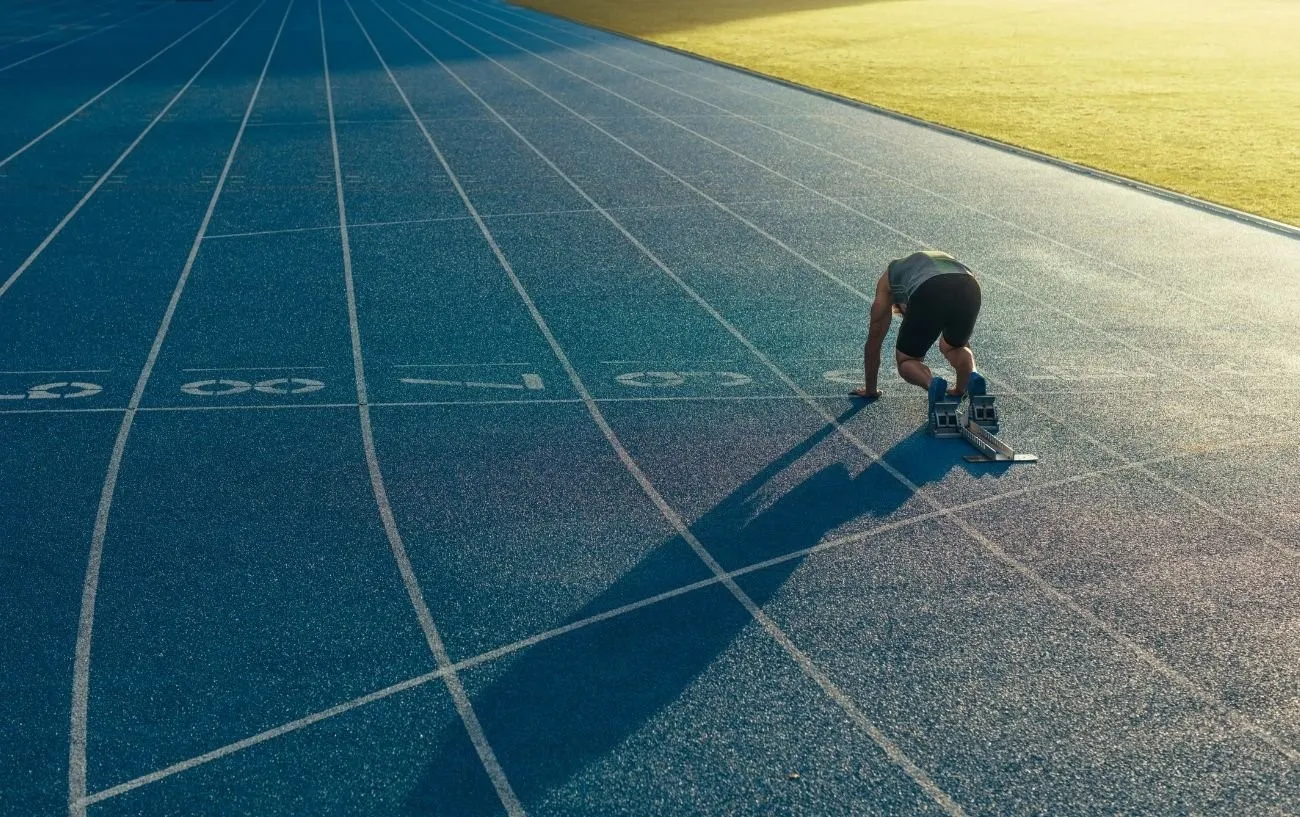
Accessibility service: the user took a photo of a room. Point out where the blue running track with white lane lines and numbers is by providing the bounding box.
[0,0,1300,817]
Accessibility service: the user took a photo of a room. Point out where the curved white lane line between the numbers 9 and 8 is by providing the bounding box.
[68,0,293,817]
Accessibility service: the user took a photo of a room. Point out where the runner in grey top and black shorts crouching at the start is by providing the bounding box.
[853,251,985,415]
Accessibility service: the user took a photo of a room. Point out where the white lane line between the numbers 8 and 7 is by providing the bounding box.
[316,0,524,817]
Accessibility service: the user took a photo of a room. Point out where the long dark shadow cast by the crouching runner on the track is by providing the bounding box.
[407,405,977,816]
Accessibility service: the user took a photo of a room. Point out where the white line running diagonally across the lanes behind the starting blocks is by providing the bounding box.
[76,424,1277,803]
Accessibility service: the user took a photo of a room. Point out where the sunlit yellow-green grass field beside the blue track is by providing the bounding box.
[512,0,1300,225]
